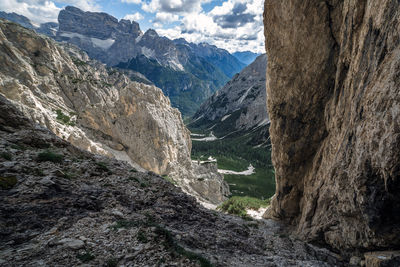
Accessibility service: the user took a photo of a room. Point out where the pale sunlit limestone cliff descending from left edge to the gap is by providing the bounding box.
[0,20,228,203]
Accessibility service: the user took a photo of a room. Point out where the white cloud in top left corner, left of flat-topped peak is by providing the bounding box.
[0,0,100,23]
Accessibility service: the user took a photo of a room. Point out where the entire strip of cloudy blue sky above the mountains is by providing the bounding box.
[0,0,265,53]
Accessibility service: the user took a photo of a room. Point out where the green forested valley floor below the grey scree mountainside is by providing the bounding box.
[188,124,275,199]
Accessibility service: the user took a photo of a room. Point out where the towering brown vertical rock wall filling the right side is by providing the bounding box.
[264,0,400,250]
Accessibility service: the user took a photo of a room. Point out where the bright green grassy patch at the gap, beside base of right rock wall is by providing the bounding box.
[218,196,269,218]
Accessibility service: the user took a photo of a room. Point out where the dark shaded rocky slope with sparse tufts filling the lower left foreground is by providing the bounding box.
[0,96,340,266]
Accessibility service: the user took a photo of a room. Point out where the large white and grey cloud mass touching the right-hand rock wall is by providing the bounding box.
[155,0,265,53]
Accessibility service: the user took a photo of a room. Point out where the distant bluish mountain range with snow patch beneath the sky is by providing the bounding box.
[0,6,250,116]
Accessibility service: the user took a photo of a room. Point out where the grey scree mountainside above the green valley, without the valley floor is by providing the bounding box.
[189,54,269,142]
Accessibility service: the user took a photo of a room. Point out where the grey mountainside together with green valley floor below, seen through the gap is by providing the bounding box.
[187,54,275,199]
